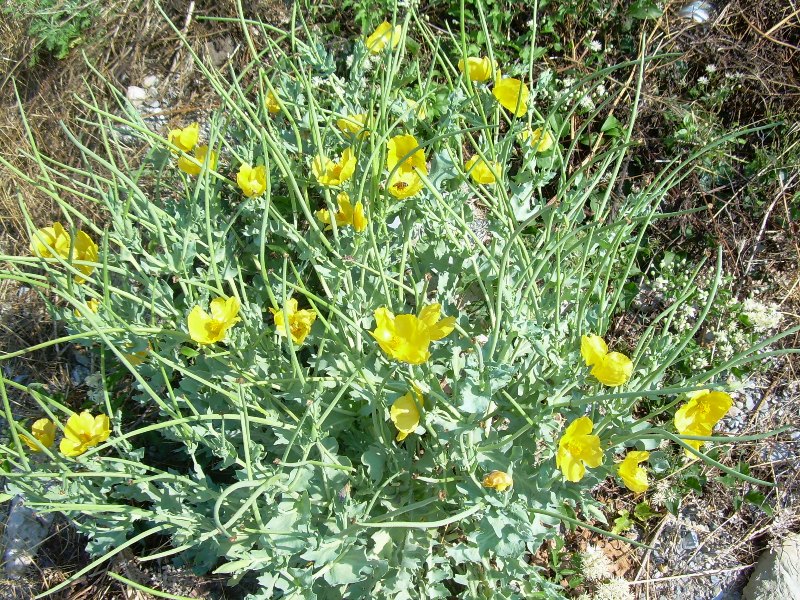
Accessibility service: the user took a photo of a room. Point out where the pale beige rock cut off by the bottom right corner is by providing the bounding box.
[742,533,800,600]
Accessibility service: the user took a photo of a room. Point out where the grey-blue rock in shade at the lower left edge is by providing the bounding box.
[3,496,54,579]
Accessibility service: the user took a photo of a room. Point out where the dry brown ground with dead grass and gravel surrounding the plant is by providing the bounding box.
[0,0,800,600]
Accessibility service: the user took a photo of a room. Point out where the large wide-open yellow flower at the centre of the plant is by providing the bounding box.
[370,303,456,365]
